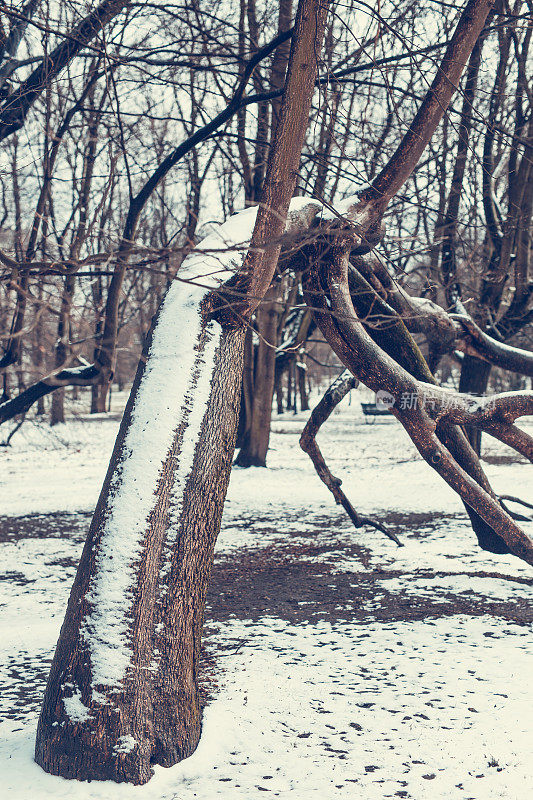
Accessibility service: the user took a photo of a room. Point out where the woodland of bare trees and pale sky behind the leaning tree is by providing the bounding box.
[0,0,533,450]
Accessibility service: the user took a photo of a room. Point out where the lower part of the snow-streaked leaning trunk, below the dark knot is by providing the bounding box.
[36,296,244,783]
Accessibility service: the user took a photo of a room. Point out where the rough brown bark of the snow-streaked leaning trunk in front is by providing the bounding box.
[36,312,244,783]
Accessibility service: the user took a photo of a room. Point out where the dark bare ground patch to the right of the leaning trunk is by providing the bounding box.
[206,513,533,624]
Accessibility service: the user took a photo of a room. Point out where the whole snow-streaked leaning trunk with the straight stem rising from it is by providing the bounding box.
[35,0,327,784]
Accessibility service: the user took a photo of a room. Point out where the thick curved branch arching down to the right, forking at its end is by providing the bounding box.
[306,243,533,564]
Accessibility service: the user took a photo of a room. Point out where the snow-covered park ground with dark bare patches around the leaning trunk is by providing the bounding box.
[0,392,533,800]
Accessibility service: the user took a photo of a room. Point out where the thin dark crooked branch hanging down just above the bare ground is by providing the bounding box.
[300,370,403,547]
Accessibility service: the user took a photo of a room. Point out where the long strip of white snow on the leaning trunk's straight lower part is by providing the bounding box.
[82,274,214,689]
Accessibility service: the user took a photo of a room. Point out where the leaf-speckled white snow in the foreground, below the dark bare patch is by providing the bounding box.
[0,616,533,800]
